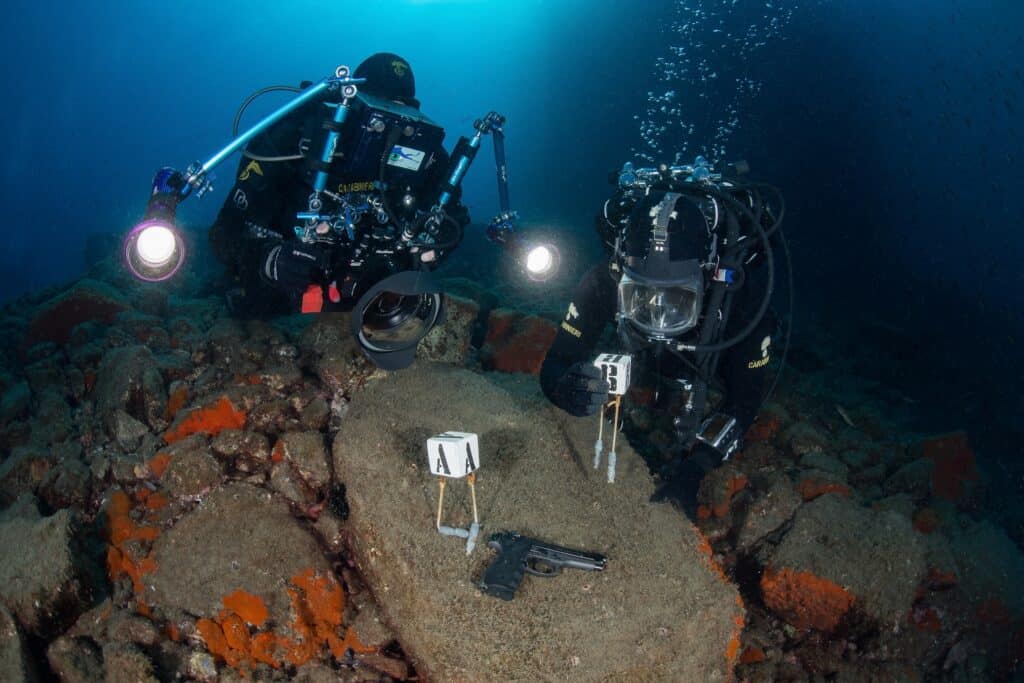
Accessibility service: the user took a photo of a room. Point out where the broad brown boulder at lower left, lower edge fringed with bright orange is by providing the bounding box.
[142,483,329,624]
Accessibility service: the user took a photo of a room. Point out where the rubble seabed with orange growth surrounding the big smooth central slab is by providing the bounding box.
[0,258,1024,682]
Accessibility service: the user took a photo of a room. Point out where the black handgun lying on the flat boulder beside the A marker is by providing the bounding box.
[479,531,607,600]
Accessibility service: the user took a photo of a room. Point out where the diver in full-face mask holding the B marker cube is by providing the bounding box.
[541,157,784,518]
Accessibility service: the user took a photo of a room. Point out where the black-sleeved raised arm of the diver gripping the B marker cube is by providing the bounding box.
[541,262,615,412]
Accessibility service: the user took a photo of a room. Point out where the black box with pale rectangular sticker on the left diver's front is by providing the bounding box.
[334,92,444,188]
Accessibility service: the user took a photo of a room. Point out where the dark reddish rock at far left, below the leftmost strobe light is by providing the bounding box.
[25,279,128,347]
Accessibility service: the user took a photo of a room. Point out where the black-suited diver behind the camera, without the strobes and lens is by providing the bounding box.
[209,52,469,325]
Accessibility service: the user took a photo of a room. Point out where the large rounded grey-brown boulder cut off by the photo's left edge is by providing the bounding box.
[0,510,98,638]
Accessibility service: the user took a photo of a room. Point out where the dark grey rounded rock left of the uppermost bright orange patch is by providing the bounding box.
[93,346,167,435]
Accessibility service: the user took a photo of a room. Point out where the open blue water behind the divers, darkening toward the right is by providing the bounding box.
[0,0,1024,458]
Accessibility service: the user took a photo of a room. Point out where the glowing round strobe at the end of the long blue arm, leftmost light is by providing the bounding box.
[124,168,185,283]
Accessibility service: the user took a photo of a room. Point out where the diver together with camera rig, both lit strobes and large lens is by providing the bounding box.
[122,52,528,370]
